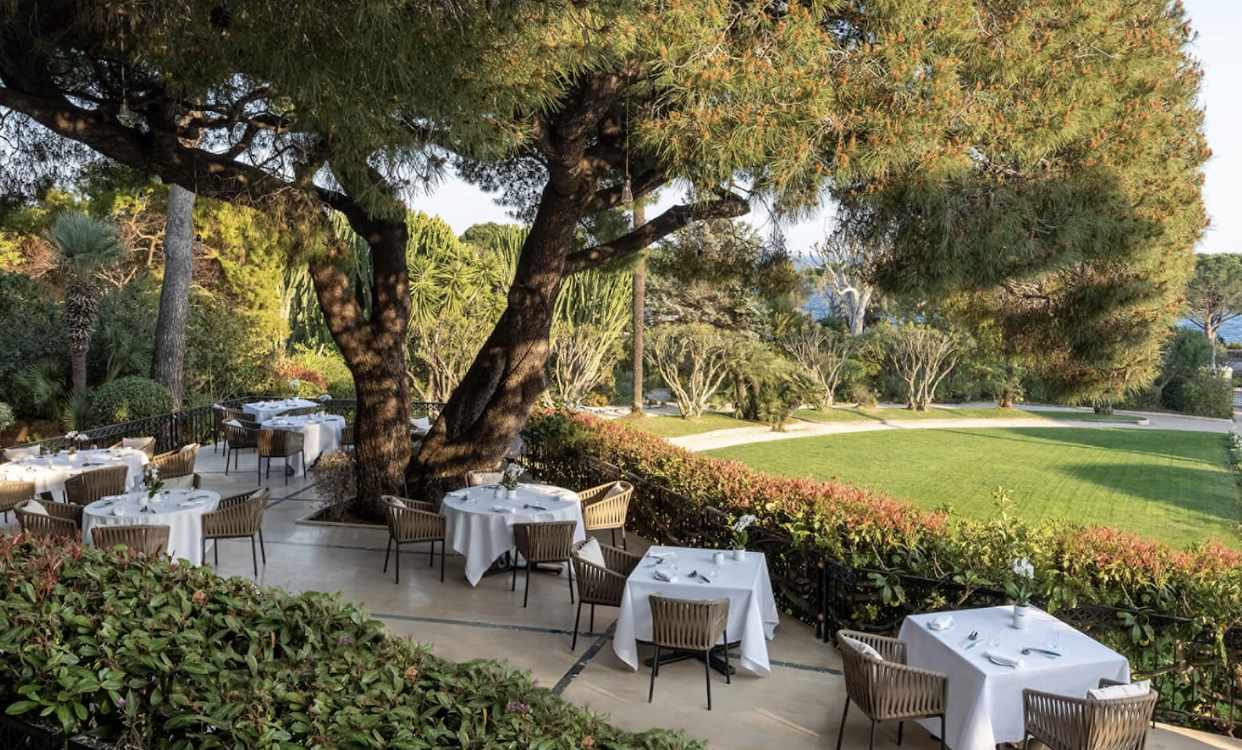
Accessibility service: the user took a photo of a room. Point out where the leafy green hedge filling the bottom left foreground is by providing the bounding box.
[0,535,703,750]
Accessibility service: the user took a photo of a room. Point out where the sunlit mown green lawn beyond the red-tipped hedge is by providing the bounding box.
[708,427,1242,546]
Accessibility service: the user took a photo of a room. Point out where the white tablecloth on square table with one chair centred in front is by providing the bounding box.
[612,546,780,677]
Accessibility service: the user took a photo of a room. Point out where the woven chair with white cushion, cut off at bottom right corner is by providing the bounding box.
[1022,680,1160,750]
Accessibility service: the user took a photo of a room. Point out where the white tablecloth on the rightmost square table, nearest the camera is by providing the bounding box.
[900,606,1130,750]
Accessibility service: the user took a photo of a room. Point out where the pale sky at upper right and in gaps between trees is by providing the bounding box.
[412,0,1242,255]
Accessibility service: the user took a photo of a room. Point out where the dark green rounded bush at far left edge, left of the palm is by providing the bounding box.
[0,272,68,416]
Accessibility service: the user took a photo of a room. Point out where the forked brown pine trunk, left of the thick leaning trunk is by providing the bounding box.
[311,217,410,518]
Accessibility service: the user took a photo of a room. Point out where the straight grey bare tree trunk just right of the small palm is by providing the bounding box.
[152,185,197,411]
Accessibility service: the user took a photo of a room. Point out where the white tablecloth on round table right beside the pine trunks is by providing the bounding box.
[441,484,586,586]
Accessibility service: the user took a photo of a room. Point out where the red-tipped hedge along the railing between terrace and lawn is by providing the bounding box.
[528,412,1242,726]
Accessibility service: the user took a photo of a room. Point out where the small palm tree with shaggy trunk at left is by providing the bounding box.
[47,211,125,391]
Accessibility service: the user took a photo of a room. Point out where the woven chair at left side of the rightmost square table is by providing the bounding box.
[837,631,949,750]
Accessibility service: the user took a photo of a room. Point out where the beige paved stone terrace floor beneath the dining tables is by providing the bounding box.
[12,447,1242,750]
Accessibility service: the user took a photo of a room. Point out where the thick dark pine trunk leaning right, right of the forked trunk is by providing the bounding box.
[411,185,590,484]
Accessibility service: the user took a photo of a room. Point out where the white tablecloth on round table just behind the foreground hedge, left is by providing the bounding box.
[82,489,220,565]
